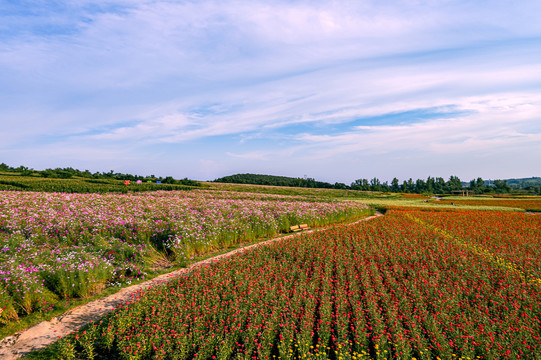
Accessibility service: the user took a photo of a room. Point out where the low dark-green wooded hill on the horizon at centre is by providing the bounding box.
[214,174,348,189]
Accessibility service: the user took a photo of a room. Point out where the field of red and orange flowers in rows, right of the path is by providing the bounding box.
[50,210,541,359]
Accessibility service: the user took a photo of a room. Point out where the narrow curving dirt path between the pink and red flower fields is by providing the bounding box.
[0,213,382,360]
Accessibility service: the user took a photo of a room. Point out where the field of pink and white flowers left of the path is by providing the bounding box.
[0,190,367,324]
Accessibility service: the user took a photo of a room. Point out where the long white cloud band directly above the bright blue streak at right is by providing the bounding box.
[75,56,541,143]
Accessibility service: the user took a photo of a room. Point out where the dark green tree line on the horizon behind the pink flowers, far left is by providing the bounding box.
[0,163,200,186]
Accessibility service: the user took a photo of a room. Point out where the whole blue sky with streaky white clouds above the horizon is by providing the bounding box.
[0,0,541,184]
